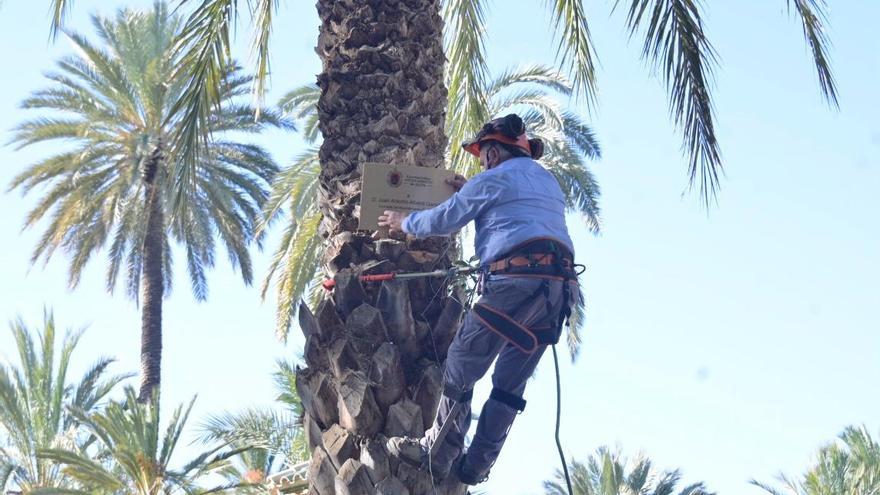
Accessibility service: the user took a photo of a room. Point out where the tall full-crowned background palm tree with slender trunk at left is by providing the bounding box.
[10,3,292,400]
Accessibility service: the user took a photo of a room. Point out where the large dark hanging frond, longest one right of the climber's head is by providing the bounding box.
[615,0,723,206]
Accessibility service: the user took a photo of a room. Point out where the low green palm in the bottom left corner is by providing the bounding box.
[0,312,128,493]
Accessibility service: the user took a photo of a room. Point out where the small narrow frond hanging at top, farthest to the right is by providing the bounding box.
[786,0,840,108]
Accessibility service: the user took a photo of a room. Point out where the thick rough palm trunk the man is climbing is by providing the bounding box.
[297,0,462,495]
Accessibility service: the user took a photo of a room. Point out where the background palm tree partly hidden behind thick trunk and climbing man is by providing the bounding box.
[259,65,601,356]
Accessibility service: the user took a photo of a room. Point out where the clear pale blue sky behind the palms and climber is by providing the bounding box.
[0,0,880,494]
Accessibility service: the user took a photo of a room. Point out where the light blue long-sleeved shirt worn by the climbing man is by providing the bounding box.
[402,158,574,263]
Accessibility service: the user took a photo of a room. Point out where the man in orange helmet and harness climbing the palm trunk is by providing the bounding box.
[379,114,578,485]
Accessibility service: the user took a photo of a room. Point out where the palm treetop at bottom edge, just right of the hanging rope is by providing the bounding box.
[544,447,714,495]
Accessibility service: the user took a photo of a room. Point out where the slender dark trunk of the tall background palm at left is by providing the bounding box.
[138,143,165,402]
